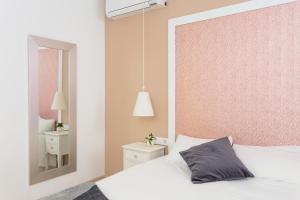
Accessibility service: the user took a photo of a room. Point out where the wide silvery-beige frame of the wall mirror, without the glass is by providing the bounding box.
[28,35,77,185]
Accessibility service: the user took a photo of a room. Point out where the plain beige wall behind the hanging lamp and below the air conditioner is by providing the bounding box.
[105,0,243,175]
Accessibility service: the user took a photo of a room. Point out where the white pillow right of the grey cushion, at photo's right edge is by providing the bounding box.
[233,144,300,183]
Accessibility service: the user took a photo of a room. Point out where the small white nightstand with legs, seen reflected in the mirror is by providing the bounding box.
[45,131,70,168]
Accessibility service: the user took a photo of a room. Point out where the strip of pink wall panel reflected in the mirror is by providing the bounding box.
[39,49,58,120]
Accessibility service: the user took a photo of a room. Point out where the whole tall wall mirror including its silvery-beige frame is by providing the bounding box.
[28,36,76,184]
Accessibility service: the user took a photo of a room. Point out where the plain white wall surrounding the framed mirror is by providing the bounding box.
[0,0,105,200]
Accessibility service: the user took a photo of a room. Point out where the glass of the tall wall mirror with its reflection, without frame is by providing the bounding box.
[38,47,70,172]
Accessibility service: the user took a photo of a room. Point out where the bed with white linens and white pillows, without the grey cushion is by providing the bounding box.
[89,135,300,200]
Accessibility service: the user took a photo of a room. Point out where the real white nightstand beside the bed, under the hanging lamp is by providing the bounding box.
[122,142,166,169]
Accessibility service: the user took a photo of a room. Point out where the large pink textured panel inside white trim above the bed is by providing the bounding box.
[176,1,300,145]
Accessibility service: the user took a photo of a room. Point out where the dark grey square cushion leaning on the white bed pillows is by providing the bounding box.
[179,137,254,183]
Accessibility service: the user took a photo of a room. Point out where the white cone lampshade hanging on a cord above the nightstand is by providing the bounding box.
[133,91,154,117]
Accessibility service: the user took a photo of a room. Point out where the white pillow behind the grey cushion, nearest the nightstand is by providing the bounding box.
[167,135,233,175]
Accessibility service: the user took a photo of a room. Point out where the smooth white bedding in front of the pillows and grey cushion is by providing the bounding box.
[97,157,300,200]
